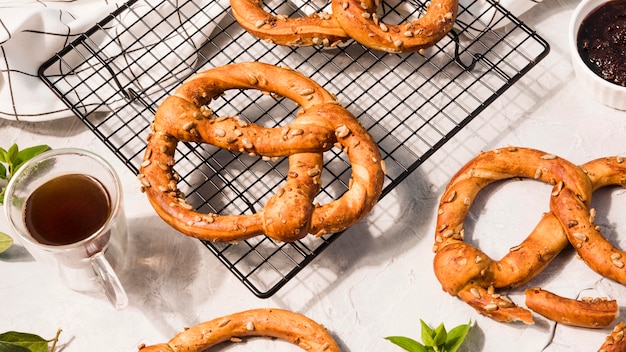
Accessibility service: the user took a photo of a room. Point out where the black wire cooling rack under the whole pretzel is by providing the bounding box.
[40,0,549,298]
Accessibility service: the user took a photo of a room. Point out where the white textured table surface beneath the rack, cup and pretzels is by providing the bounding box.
[0,0,626,352]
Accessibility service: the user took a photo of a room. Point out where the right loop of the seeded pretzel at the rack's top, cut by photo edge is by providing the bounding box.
[332,0,459,53]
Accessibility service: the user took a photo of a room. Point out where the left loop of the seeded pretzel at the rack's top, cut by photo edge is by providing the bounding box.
[230,0,350,47]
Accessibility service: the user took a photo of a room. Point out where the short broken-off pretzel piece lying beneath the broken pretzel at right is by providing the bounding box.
[526,288,619,329]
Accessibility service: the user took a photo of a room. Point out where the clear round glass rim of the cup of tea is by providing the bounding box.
[4,148,123,252]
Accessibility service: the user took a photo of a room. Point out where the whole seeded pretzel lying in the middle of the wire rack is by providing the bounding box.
[138,62,384,242]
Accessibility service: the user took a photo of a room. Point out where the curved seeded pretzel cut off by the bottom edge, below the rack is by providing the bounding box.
[139,309,340,352]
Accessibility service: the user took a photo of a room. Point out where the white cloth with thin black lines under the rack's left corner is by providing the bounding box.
[0,0,228,121]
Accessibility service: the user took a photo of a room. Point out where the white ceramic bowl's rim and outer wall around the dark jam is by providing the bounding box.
[568,0,626,110]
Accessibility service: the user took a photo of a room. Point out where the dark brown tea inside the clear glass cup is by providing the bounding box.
[24,174,111,246]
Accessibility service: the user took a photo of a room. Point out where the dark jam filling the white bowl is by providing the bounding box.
[577,0,626,87]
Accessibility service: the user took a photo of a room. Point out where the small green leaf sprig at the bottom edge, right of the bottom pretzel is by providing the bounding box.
[385,319,472,352]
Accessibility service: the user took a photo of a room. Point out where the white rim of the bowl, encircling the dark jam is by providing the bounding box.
[568,0,626,94]
